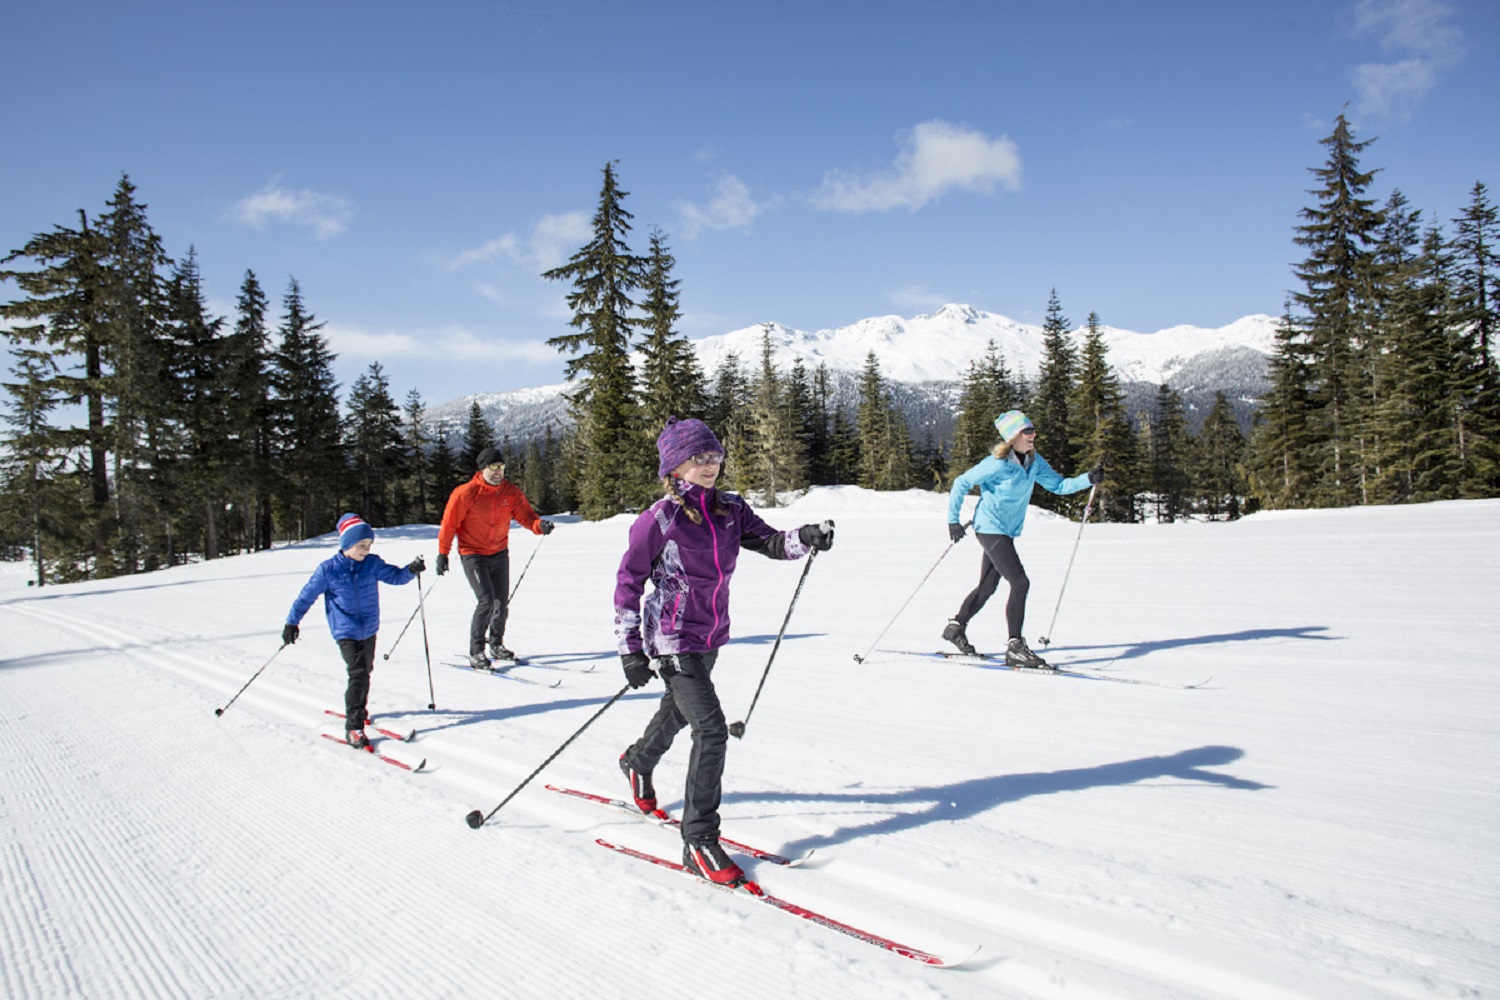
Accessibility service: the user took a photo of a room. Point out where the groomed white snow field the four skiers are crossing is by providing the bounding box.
[0,487,1500,1000]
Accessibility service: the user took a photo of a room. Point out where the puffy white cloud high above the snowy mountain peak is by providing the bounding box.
[813,120,1022,213]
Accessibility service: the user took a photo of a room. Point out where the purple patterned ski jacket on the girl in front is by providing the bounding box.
[615,483,810,657]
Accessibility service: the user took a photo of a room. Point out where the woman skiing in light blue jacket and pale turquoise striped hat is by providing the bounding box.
[942,409,1104,669]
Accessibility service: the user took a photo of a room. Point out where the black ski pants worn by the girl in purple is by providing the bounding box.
[626,649,729,844]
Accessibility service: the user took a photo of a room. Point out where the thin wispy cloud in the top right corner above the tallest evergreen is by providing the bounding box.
[1350,0,1464,117]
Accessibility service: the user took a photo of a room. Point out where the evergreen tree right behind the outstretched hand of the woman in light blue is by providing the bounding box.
[1068,312,1136,520]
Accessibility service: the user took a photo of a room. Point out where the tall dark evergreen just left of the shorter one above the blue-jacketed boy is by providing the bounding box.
[272,279,345,538]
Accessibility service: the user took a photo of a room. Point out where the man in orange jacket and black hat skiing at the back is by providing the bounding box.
[437,448,552,670]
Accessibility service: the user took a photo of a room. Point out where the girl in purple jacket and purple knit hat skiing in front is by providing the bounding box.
[615,417,834,885]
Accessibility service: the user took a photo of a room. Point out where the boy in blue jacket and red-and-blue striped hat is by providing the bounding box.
[282,514,428,750]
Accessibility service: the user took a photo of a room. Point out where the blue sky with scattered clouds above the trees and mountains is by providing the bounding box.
[0,0,1500,403]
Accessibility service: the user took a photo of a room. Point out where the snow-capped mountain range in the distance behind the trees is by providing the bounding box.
[429,304,1277,445]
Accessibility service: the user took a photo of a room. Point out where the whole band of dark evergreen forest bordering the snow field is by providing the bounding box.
[0,115,1500,585]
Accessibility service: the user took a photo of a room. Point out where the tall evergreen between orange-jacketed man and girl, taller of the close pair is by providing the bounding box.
[543,163,656,520]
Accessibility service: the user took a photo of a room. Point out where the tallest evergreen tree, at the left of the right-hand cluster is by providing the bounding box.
[1293,114,1382,505]
